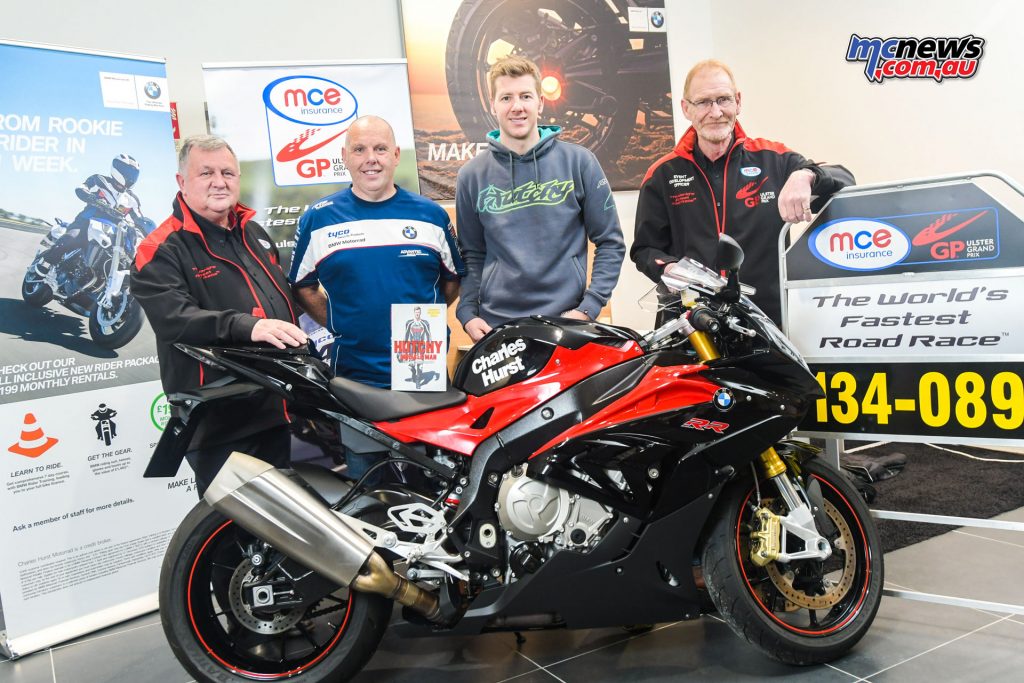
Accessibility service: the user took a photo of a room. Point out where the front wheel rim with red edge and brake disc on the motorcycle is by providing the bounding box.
[735,475,873,638]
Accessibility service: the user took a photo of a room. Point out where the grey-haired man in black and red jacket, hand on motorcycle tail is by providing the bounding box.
[131,135,306,498]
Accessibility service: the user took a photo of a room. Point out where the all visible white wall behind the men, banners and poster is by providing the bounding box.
[6,0,1024,328]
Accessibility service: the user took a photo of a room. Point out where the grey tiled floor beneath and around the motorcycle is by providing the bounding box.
[0,508,1024,683]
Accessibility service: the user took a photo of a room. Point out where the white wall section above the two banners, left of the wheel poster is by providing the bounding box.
[0,0,404,137]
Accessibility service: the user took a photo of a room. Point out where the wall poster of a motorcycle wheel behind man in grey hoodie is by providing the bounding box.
[401,0,675,200]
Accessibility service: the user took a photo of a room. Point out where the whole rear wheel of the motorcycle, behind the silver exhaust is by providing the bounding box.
[160,503,392,683]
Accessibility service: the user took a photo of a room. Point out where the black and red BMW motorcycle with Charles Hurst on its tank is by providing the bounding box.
[147,233,883,682]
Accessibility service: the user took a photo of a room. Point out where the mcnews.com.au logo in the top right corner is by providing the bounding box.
[846,34,985,83]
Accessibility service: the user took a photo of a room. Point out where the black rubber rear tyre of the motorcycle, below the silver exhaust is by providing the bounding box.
[160,502,393,683]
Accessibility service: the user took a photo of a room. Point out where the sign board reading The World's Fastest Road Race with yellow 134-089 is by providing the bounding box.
[784,174,1024,444]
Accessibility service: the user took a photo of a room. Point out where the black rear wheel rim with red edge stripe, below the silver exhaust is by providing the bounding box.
[185,520,354,681]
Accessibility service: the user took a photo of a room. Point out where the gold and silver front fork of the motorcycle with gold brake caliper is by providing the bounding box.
[680,325,831,566]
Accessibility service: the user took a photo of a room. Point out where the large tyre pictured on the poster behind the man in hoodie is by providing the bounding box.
[444,0,640,163]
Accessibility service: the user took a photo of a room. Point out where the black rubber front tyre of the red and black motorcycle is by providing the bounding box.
[702,460,884,666]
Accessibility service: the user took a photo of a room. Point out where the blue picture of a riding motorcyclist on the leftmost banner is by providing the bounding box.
[0,43,177,404]
